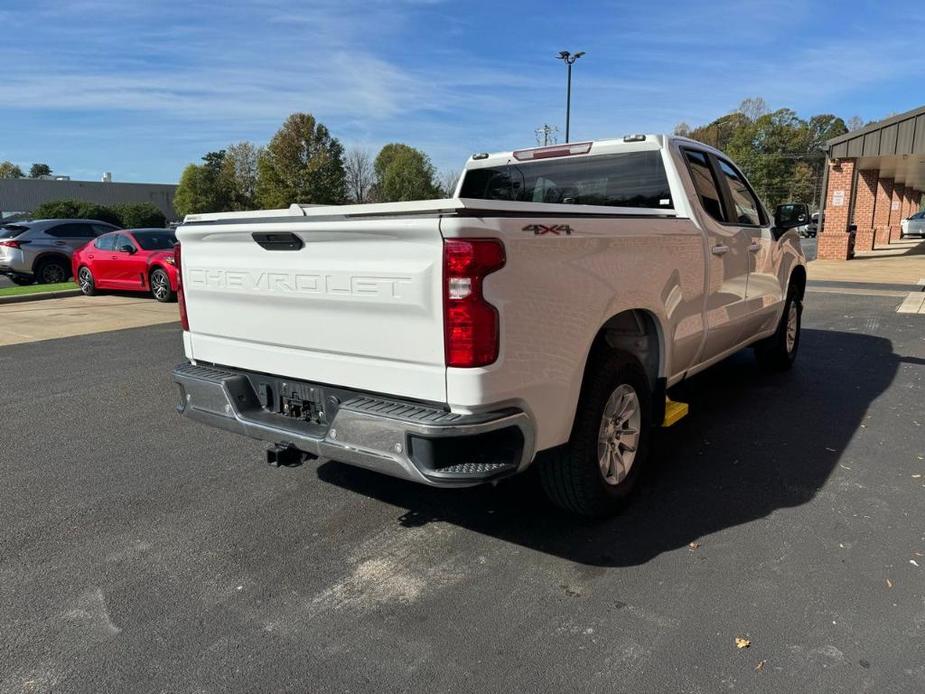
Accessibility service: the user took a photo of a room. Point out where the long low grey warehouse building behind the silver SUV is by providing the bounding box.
[0,178,177,221]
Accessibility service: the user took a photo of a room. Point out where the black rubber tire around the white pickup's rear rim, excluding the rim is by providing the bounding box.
[539,351,652,517]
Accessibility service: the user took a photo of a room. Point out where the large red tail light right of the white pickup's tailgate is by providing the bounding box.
[443,239,505,368]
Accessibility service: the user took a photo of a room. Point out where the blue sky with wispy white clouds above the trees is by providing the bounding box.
[0,0,925,182]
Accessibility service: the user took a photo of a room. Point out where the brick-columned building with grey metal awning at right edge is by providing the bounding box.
[818,106,925,260]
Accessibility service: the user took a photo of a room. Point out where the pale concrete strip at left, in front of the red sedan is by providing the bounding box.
[0,295,180,346]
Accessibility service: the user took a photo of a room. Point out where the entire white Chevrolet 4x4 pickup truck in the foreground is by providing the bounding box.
[173,135,808,515]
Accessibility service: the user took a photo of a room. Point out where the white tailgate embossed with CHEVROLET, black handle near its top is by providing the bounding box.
[177,216,446,402]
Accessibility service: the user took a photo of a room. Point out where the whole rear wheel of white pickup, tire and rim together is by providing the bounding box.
[540,352,652,517]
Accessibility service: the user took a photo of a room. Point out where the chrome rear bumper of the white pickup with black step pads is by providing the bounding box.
[173,364,534,487]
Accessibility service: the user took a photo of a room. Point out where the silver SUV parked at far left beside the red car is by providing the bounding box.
[0,219,119,284]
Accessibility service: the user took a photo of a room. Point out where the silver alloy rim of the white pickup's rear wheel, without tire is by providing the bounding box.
[597,383,642,486]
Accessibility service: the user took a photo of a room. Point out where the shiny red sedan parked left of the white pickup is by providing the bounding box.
[71,229,177,301]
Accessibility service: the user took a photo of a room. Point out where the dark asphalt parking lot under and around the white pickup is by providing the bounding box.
[0,293,925,692]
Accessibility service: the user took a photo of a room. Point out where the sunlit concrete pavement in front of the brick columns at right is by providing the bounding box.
[807,239,925,285]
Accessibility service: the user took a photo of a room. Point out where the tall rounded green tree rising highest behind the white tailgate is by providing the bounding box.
[256,113,347,208]
